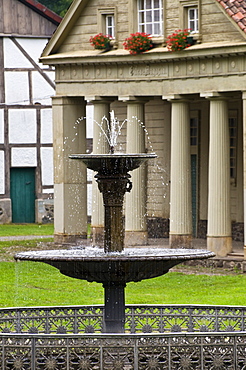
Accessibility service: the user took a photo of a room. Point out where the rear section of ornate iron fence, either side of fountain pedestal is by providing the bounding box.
[0,305,246,334]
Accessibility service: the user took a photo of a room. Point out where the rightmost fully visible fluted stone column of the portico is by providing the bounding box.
[203,93,232,257]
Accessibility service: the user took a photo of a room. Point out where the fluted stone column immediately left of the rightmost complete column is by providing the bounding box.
[164,96,192,248]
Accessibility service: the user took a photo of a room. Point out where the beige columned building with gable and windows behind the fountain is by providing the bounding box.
[41,0,246,256]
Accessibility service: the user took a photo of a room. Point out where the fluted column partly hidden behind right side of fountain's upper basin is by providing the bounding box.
[120,97,148,245]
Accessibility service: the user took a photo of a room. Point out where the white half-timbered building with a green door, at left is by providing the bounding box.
[0,0,61,223]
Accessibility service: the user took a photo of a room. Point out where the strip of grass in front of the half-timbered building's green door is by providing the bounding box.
[0,224,54,236]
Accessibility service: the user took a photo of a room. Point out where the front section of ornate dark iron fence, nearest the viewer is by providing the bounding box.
[0,332,246,370]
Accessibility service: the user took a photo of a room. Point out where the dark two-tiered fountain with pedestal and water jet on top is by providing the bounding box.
[15,112,214,333]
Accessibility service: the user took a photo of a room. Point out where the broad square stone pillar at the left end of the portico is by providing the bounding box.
[53,96,87,243]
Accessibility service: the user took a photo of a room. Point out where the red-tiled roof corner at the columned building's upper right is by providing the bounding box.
[217,0,246,33]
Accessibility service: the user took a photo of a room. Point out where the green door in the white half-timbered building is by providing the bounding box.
[10,167,35,223]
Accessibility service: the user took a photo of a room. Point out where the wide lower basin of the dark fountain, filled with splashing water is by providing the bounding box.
[15,247,214,285]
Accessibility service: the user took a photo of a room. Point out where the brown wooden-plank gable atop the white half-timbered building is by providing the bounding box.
[0,0,61,37]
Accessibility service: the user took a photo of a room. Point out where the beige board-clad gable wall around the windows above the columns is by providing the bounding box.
[42,0,246,57]
